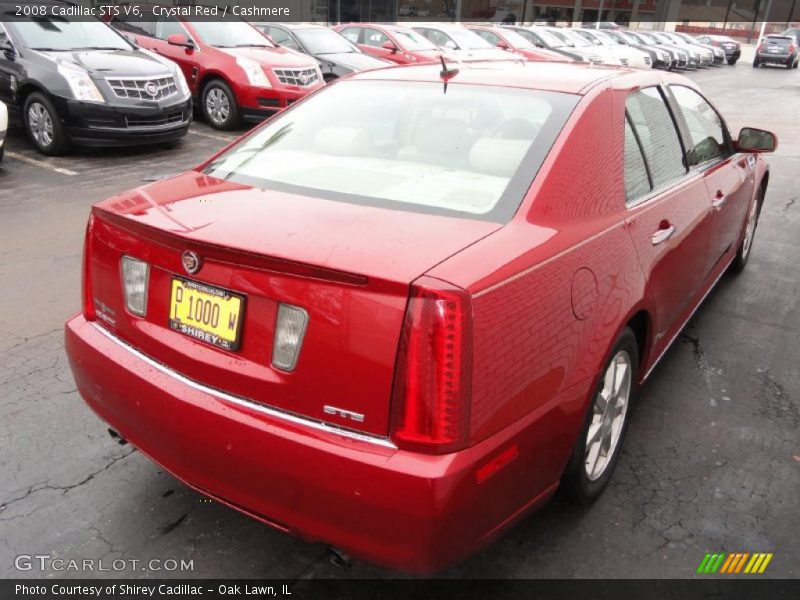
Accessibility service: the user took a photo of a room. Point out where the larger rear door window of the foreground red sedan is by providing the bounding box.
[625,87,686,188]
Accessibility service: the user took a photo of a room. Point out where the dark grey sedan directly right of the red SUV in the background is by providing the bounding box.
[253,23,394,81]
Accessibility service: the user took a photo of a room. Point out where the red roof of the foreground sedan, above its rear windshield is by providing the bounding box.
[349,61,637,94]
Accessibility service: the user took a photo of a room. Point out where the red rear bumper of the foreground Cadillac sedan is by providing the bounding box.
[65,315,557,573]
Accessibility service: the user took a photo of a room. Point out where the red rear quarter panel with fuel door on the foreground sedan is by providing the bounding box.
[432,89,646,489]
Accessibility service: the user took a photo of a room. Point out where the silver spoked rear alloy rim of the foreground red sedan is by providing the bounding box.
[584,350,633,481]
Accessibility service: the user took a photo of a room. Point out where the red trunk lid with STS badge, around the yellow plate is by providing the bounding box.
[88,172,500,436]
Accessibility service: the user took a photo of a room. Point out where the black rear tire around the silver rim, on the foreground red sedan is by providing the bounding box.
[561,327,639,504]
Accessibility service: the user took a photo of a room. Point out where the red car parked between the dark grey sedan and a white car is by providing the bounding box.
[333,23,442,65]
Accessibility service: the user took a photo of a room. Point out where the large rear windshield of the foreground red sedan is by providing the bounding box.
[206,80,578,222]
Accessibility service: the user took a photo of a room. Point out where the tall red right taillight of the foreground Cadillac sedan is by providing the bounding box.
[392,277,472,454]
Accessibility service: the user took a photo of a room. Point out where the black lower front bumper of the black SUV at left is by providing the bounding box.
[56,98,192,146]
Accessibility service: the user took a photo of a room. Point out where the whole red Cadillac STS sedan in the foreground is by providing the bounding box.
[66,62,777,573]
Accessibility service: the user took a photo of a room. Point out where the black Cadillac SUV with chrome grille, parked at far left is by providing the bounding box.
[0,0,192,155]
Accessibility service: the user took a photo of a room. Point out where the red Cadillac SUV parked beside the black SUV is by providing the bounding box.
[111,14,324,130]
